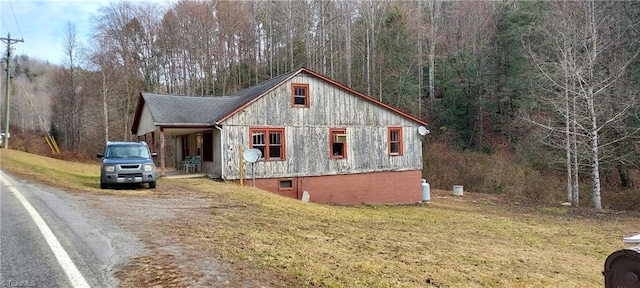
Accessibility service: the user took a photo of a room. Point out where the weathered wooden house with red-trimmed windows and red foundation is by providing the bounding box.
[131,68,427,204]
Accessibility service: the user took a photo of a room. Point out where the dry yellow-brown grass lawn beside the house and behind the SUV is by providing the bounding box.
[0,150,640,287]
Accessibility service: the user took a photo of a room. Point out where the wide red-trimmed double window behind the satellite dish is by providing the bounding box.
[249,128,285,160]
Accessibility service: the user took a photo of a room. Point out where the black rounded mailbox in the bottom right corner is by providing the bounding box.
[602,245,640,288]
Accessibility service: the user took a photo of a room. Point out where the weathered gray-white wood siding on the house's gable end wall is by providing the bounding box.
[222,73,422,179]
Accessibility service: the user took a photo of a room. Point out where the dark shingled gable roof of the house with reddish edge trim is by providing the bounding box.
[131,68,427,134]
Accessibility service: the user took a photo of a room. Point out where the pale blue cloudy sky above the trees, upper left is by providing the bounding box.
[0,0,109,64]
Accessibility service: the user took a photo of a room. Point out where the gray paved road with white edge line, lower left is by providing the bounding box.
[0,172,144,287]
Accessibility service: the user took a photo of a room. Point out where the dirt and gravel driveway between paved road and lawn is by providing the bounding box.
[85,180,289,287]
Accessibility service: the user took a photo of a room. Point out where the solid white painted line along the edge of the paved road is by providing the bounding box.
[0,173,90,288]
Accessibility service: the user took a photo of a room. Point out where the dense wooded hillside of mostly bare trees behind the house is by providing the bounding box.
[2,0,640,210]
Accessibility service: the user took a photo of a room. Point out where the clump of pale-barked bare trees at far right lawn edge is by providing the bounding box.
[531,1,639,209]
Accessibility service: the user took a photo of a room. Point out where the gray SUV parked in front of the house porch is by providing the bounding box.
[97,142,157,189]
